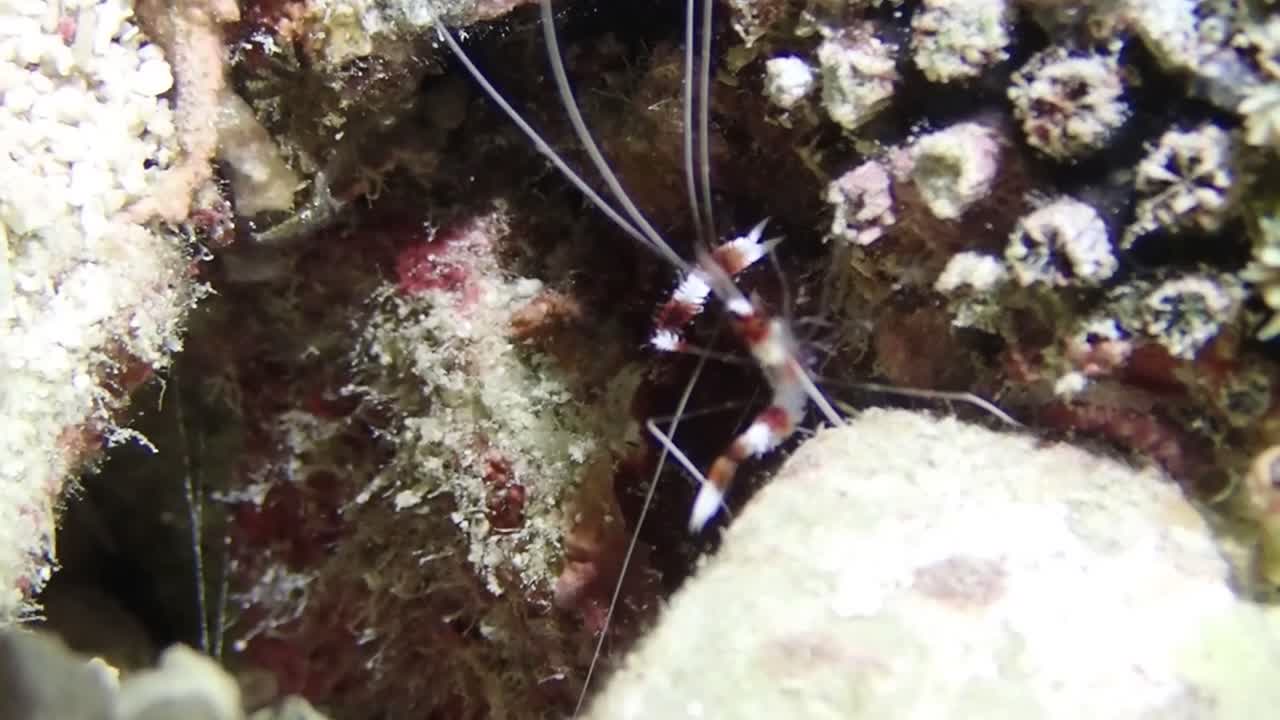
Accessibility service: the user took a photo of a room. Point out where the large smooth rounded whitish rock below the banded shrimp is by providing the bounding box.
[589,410,1280,720]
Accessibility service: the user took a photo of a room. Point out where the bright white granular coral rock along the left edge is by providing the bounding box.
[0,0,198,624]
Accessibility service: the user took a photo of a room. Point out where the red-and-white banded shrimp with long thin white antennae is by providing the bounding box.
[435,0,1016,711]
